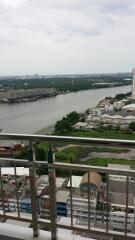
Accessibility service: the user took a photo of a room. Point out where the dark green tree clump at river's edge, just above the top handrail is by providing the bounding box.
[55,111,79,133]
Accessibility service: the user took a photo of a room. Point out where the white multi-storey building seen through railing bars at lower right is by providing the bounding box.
[67,198,135,232]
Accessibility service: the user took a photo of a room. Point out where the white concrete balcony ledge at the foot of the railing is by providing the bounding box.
[0,223,94,240]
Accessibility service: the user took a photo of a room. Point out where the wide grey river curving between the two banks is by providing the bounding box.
[0,86,131,133]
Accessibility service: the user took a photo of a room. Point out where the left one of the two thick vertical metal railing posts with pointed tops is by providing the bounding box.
[29,142,39,237]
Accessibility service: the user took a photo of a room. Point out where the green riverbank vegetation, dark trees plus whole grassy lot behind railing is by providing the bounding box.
[16,106,135,175]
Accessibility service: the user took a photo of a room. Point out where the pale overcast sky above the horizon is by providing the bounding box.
[0,0,135,75]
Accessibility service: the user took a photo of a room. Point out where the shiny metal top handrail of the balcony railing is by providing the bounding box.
[0,133,135,148]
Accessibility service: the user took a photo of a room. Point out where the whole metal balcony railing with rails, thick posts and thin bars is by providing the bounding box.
[0,133,135,240]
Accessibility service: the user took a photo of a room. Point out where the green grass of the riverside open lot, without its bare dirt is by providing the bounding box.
[25,130,135,170]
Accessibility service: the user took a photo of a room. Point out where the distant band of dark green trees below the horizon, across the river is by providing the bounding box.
[0,74,131,92]
